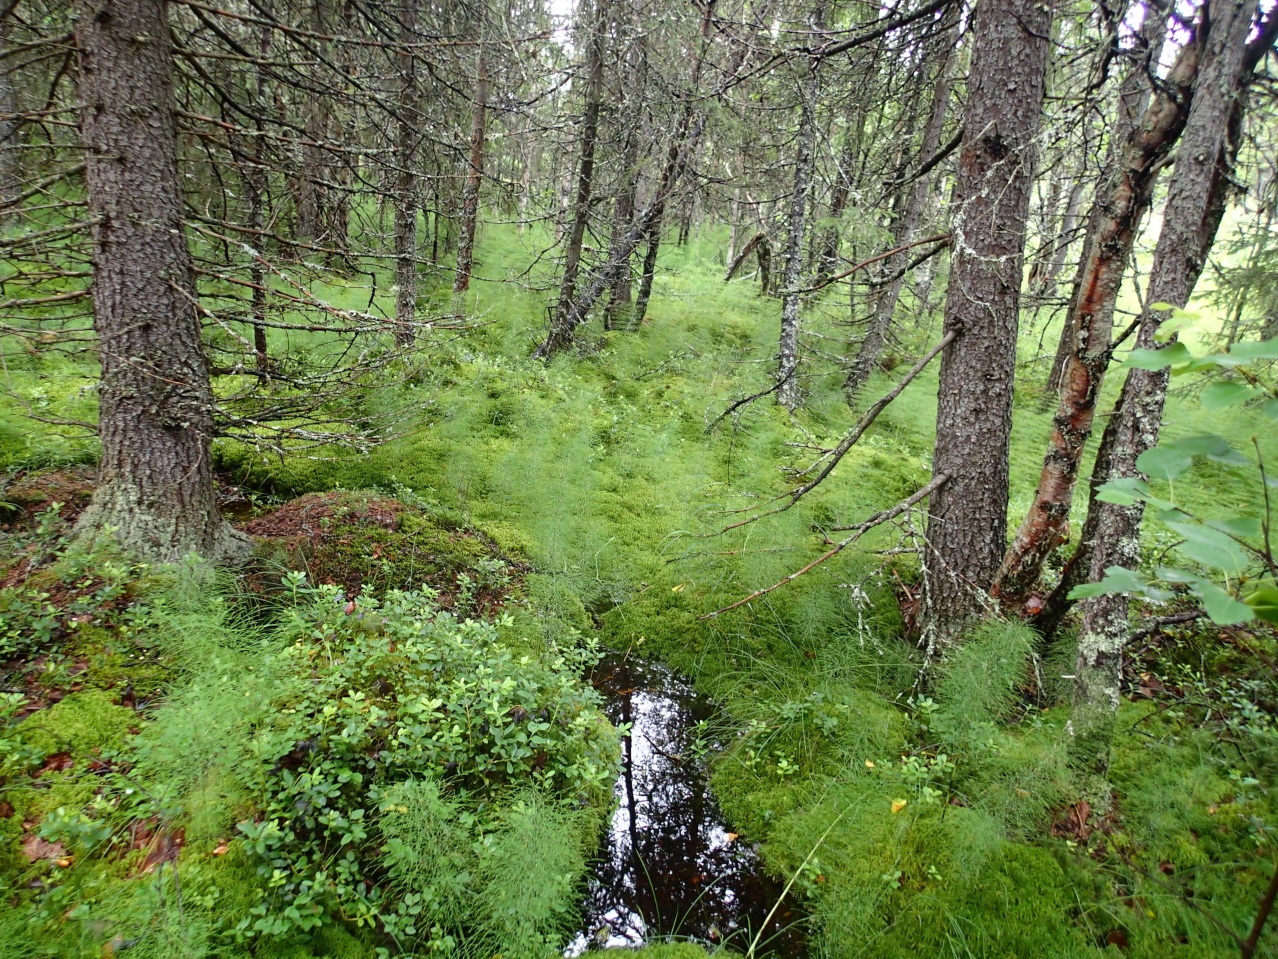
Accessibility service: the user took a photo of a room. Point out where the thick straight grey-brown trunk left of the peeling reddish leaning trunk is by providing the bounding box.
[924,0,1052,648]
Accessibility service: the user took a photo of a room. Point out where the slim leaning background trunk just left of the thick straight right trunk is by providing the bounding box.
[843,34,959,404]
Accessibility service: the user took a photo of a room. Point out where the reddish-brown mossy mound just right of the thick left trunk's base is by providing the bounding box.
[244,491,528,615]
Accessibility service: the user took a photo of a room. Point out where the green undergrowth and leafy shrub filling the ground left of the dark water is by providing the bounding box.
[0,537,617,959]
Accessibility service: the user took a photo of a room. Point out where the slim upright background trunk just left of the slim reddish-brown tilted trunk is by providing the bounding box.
[395,0,418,345]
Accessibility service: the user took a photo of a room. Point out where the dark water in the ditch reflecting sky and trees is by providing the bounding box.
[565,655,806,959]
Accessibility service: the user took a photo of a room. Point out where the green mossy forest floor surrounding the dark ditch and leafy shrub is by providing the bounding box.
[0,231,1278,959]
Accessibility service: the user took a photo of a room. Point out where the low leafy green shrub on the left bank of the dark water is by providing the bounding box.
[240,587,617,947]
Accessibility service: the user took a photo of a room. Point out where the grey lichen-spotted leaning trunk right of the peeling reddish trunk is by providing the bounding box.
[1071,0,1278,774]
